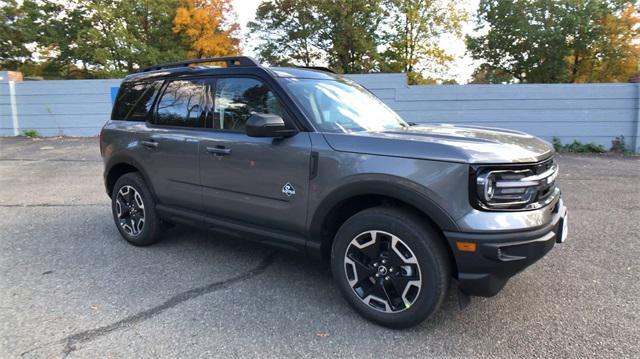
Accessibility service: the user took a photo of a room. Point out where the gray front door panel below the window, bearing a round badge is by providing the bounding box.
[199,131,311,233]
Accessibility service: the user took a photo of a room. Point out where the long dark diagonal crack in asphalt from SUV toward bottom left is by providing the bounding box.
[59,251,278,357]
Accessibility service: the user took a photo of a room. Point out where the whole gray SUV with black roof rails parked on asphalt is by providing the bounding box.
[100,57,567,328]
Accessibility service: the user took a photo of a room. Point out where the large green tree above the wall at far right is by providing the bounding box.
[467,0,628,83]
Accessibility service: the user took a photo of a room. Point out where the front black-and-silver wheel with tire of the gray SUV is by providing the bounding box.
[331,207,451,328]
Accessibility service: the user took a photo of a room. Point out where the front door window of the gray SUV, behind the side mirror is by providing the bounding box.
[213,78,287,132]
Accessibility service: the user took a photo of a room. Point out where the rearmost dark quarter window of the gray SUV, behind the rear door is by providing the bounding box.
[111,81,161,122]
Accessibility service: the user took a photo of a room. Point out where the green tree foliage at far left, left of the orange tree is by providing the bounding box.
[0,0,189,78]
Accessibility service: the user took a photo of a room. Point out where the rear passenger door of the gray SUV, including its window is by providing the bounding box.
[141,79,208,209]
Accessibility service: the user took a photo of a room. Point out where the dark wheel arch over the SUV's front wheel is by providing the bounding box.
[307,179,457,271]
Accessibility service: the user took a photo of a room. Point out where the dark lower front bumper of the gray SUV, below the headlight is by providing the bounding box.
[444,199,567,297]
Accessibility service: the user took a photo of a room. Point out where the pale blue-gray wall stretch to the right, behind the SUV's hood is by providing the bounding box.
[351,74,640,152]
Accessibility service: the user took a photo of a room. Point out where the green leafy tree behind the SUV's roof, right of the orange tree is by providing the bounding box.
[249,0,384,73]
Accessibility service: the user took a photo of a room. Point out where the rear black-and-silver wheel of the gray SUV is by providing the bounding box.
[111,172,162,246]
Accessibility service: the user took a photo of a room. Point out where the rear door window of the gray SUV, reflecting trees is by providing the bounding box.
[156,80,206,127]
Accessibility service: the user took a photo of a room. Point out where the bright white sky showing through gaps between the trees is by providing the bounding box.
[233,0,479,83]
